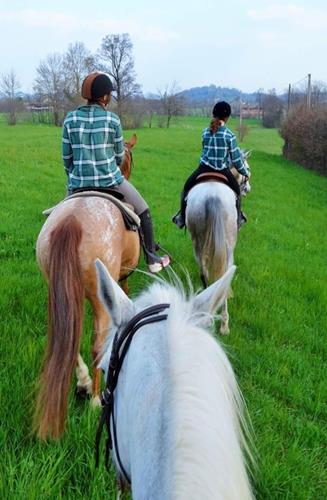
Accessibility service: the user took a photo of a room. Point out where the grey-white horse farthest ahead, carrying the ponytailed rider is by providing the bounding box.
[186,151,251,335]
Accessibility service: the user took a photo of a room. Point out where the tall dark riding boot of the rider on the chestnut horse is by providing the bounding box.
[139,210,170,273]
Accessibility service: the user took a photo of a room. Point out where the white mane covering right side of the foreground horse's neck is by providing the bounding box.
[171,304,254,500]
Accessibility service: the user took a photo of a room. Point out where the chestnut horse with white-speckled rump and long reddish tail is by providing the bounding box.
[35,136,140,439]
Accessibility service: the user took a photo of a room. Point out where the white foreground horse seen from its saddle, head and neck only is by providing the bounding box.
[96,260,253,500]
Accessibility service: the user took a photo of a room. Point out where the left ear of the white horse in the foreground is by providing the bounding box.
[95,259,134,327]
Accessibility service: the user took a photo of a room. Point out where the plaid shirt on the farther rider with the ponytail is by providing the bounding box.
[200,126,248,175]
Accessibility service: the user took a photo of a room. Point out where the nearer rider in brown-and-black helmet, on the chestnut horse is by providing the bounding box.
[62,72,170,273]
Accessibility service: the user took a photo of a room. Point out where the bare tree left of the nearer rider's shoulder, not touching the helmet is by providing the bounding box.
[34,53,65,126]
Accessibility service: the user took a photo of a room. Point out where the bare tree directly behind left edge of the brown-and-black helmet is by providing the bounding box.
[63,42,96,105]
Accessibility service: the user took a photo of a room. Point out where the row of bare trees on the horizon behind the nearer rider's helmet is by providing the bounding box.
[0,33,185,127]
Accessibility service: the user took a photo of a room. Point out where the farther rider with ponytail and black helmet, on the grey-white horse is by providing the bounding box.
[172,101,249,228]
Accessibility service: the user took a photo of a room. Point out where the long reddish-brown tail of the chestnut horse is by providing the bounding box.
[35,215,84,439]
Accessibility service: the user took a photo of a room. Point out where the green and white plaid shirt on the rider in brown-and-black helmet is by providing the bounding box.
[62,104,124,190]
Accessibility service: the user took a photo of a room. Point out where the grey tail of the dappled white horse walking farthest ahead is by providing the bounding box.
[200,197,227,280]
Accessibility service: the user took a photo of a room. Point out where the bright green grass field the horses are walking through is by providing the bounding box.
[0,117,327,500]
